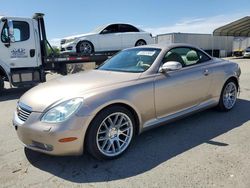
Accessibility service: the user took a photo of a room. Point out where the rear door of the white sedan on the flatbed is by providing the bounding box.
[119,24,139,49]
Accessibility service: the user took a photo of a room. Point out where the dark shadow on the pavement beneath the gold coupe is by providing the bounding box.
[25,99,250,183]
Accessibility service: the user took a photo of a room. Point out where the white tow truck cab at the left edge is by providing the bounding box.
[0,14,42,90]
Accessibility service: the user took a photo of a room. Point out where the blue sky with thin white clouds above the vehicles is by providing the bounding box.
[0,0,250,45]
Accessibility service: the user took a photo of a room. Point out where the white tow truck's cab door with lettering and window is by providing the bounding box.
[0,18,39,68]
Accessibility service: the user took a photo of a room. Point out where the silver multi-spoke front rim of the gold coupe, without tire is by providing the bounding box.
[96,112,133,157]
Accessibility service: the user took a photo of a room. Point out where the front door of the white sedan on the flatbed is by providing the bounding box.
[99,24,122,51]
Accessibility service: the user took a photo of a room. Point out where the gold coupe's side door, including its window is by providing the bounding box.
[155,48,212,118]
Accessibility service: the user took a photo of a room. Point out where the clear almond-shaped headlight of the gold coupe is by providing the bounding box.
[41,98,83,123]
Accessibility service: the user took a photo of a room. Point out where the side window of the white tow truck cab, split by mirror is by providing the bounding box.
[1,21,30,43]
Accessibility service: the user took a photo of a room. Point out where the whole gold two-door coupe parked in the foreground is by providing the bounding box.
[13,44,241,159]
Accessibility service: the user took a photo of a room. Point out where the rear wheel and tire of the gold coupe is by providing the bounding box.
[218,80,238,111]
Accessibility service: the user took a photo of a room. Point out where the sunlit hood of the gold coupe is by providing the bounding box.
[19,70,140,112]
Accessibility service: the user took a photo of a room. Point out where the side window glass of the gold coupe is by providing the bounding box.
[163,47,210,67]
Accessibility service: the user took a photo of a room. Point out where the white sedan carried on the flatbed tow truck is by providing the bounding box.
[61,24,153,55]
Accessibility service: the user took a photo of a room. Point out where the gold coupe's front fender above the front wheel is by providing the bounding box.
[77,81,155,133]
